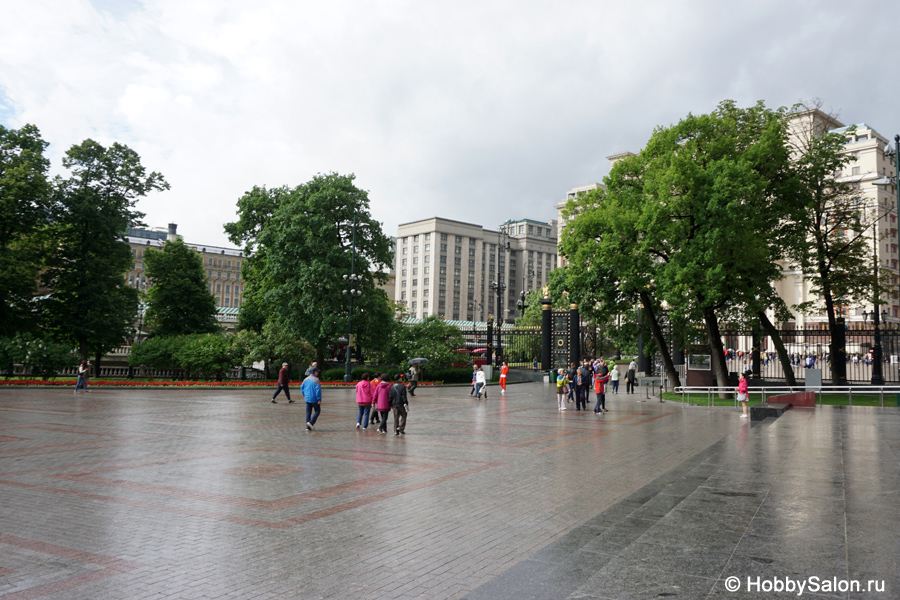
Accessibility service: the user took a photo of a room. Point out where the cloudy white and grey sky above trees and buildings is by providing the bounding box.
[0,0,900,244]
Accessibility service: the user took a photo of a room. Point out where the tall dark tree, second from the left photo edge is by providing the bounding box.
[43,140,169,371]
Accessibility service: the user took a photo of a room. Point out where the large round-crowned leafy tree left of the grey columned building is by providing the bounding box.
[225,173,393,360]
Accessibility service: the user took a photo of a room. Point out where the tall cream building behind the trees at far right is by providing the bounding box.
[775,109,900,328]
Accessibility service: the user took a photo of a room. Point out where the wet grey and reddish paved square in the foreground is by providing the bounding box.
[0,384,900,600]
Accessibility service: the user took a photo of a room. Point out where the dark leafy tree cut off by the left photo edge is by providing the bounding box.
[0,125,50,336]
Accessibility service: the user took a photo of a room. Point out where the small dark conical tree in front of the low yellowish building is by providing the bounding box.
[144,239,219,336]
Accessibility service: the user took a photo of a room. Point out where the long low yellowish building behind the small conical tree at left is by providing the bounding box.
[125,223,244,313]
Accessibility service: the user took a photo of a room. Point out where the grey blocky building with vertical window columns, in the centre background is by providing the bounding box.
[394,217,557,321]
